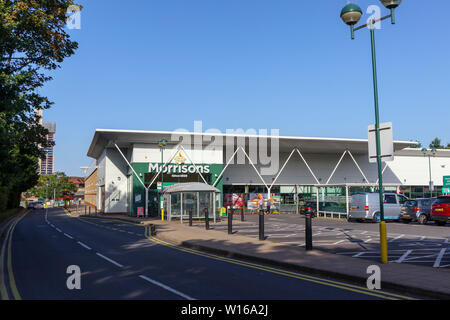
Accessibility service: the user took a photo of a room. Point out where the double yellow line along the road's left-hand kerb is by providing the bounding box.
[0,211,28,300]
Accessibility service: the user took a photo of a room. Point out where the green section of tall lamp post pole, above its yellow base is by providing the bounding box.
[370,26,384,221]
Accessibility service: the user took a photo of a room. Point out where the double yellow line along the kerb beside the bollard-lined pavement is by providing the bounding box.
[145,226,416,300]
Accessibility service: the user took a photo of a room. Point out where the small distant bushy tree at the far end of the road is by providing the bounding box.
[27,172,77,199]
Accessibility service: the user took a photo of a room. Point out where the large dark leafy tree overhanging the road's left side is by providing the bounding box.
[0,0,78,210]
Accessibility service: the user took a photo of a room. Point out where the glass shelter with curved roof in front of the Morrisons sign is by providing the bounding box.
[163,182,220,221]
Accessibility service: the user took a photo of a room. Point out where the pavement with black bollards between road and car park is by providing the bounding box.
[66,208,450,299]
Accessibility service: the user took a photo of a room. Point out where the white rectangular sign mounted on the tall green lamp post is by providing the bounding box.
[369,122,394,163]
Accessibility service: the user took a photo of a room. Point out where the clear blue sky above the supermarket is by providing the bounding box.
[41,0,450,175]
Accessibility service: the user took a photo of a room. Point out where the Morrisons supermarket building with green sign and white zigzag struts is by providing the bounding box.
[85,129,450,216]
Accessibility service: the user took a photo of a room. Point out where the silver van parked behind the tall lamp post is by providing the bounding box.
[347,192,409,222]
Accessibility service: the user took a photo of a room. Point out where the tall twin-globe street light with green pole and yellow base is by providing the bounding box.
[341,0,402,263]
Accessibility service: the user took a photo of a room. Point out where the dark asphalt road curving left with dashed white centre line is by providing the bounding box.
[0,209,418,300]
